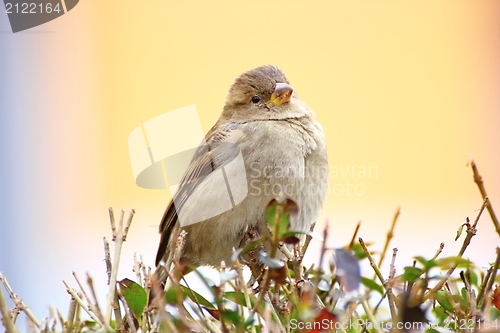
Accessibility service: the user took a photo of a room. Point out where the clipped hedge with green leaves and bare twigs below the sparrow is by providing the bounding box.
[0,162,500,333]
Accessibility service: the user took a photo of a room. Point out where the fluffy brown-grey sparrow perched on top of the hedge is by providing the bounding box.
[156,65,328,274]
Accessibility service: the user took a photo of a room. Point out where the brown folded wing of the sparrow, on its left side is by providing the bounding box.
[156,123,235,266]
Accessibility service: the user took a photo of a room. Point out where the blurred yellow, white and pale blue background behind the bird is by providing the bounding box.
[0,0,500,318]
